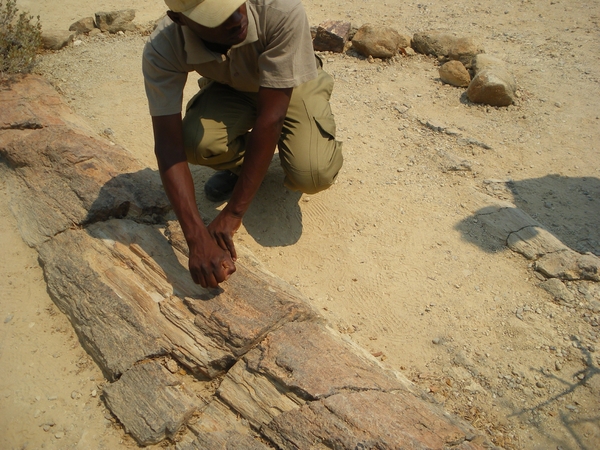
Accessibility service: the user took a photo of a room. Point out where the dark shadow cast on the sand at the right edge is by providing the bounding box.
[455,175,600,256]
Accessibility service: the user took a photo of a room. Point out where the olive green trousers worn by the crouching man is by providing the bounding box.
[183,69,343,194]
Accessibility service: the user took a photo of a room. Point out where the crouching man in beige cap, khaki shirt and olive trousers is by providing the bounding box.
[143,0,342,287]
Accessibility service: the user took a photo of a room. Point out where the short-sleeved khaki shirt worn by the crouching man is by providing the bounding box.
[142,0,317,116]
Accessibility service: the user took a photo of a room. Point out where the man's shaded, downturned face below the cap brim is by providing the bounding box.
[169,3,248,47]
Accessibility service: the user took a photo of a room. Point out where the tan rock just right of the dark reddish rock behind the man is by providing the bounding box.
[352,24,410,58]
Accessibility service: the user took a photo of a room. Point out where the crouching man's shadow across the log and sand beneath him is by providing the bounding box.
[81,163,302,298]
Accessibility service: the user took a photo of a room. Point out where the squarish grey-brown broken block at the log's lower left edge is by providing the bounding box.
[104,361,201,445]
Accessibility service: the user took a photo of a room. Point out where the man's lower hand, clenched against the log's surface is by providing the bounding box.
[189,232,235,288]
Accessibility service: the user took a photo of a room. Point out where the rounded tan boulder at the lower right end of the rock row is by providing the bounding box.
[467,68,517,106]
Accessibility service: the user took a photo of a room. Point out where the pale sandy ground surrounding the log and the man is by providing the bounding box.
[0,0,600,450]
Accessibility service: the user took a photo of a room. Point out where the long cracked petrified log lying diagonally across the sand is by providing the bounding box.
[0,77,488,450]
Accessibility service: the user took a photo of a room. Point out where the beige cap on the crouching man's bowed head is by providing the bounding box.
[165,0,246,28]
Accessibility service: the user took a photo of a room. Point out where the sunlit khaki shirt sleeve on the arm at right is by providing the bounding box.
[258,1,317,88]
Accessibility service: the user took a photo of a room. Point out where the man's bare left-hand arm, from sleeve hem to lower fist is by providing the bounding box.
[152,114,235,287]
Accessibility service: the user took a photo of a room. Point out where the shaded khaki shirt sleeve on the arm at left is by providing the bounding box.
[142,19,191,116]
